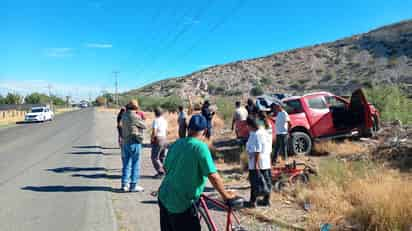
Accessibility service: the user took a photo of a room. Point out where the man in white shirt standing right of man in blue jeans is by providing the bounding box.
[151,108,168,178]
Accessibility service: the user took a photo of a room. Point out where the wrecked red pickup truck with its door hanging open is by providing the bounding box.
[243,89,380,155]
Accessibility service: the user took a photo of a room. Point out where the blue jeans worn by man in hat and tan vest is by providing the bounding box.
[122,143,142,186]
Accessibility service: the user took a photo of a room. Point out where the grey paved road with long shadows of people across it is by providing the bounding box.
[0,109,117,231]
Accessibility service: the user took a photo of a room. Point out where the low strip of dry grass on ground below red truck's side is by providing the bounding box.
[314,140,368,156]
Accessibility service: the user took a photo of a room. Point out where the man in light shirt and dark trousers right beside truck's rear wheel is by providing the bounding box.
[271,103,290,163]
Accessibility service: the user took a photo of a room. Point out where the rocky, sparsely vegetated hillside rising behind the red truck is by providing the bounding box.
[125,20,412,96]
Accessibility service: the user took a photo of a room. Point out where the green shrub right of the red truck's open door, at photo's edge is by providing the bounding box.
[366,85,412,124]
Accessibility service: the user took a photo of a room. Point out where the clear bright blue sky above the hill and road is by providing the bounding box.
[0,0,412,98]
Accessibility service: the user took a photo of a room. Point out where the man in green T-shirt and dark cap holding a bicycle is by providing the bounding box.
[159,115,234,231]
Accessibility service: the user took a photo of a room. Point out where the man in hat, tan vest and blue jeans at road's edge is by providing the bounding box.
[121,100,146,192]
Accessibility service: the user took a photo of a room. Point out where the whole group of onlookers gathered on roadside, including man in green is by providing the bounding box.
[117,100,288,231]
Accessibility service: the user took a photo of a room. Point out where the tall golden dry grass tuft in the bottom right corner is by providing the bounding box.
[348,174,412,230]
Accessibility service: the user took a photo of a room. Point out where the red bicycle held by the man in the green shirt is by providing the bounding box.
[197,194,246,231]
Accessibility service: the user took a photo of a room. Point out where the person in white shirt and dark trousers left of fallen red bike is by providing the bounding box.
[246,118,272,208]
